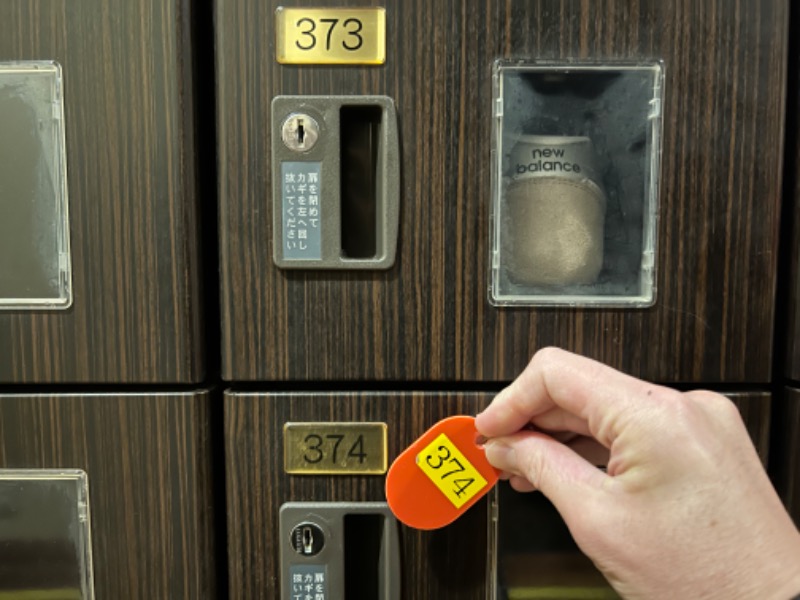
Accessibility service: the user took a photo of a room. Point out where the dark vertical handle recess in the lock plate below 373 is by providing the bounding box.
[339,104,383,259]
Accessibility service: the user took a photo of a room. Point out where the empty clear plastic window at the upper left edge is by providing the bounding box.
[0,61,72,310]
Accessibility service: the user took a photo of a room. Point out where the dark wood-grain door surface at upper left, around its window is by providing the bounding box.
[0,0,203,383]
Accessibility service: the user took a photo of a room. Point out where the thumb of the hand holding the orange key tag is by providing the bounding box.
[485,431,611,521]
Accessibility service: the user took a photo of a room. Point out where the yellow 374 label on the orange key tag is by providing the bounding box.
[417,434,488,508]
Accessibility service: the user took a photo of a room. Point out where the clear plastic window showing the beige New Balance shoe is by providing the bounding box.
[490,61,663,307]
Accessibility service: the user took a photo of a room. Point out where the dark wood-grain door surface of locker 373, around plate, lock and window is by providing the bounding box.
[216,0,789,382]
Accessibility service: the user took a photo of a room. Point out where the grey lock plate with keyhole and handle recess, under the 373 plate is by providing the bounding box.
[272,96,401,270]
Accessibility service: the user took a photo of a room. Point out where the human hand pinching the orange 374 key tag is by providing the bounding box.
[476,348,800,600]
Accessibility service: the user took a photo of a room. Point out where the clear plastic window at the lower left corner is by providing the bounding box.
[0,469,94,600]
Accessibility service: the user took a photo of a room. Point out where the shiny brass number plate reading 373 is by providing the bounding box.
[275,7,386,65]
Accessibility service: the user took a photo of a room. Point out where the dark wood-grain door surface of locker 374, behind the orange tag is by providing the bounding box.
[225,392,770,600]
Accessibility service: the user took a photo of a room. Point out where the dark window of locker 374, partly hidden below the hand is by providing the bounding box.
[489,481,620,600]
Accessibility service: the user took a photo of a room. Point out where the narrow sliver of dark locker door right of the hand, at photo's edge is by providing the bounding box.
[772,388,800,527]
